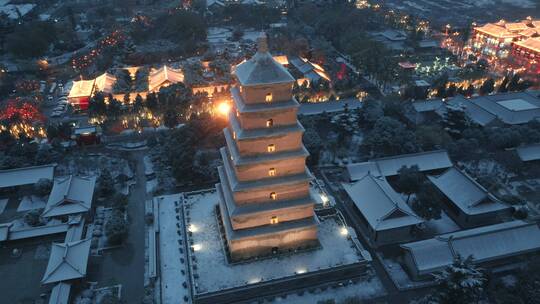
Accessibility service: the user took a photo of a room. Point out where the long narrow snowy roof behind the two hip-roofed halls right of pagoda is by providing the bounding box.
[347,150,452,181]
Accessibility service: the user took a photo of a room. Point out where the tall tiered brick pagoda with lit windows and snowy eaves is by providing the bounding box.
[216,34,319,261]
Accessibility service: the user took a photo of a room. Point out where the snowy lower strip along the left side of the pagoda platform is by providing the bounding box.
[157,194,189,304]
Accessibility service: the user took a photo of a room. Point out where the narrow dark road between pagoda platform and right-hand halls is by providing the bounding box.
[313,169,427,303]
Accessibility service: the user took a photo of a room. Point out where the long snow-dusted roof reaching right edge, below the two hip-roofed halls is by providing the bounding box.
[401,221,540,275]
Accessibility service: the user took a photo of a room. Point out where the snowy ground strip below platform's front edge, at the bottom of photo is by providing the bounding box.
[274,277,386,304]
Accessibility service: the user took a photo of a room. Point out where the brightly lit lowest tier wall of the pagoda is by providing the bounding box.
[218,197,320,263]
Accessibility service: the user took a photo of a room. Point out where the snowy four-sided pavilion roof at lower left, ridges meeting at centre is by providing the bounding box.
[41,238,91,284]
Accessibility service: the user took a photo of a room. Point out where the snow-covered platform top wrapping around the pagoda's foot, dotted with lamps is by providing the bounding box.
[184,192,362,293]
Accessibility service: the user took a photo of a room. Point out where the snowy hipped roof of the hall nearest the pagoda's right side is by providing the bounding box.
[343,174,423,231]
